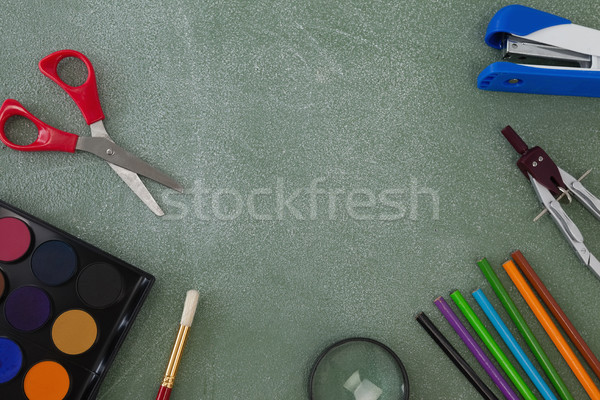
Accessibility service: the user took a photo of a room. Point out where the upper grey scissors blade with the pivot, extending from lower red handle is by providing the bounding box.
[75,136,183,193]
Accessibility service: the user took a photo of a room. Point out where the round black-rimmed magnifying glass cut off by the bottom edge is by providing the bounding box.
[308,337,409,400]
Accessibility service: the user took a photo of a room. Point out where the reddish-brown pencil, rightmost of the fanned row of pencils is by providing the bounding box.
[511,250,600,379]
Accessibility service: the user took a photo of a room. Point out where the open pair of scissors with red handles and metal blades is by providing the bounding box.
[0,50,183,216]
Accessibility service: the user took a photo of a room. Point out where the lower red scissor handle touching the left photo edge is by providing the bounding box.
[0,99,79,153]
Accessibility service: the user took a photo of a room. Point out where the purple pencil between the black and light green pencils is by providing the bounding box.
[434,296,519,400]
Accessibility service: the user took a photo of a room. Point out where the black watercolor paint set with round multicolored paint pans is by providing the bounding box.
[0,202,154,400]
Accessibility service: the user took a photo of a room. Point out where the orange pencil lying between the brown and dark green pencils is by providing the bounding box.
[502,260,600,400]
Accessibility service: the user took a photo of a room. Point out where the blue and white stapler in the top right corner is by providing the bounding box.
[477,5,600,97]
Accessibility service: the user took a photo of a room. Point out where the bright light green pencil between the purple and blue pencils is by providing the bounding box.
[450,290,537,400]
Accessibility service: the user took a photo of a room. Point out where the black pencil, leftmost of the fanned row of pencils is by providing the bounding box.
[416,312,498,400]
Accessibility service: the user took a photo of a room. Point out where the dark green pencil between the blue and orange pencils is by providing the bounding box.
[477,258,574,400]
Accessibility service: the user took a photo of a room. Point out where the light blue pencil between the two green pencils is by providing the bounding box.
[473,289,557,400]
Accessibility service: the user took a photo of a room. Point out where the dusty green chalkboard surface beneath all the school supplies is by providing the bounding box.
[0,0,600,400]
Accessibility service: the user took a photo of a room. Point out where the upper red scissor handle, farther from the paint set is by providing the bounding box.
[39,50,104,125]
